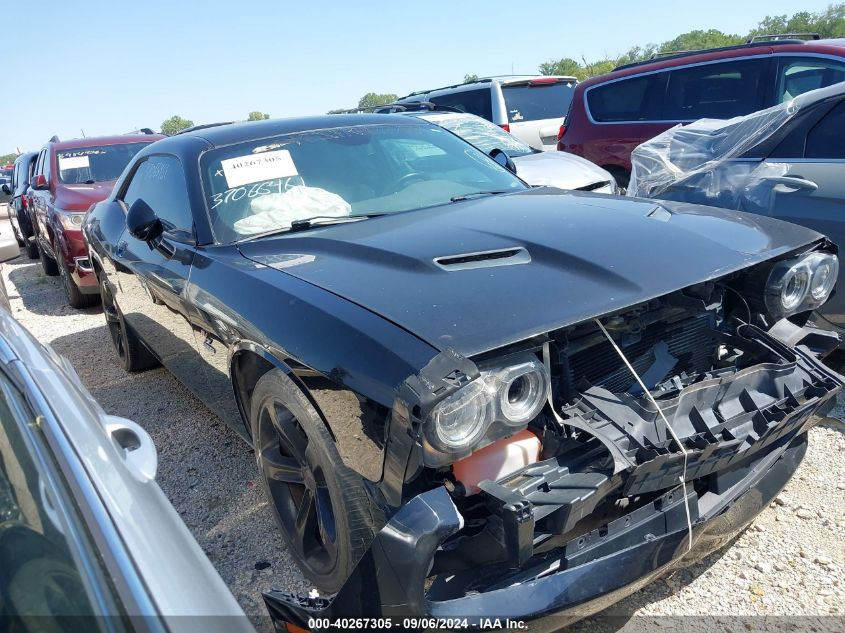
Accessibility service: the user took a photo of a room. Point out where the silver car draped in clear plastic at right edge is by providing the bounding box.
[628,82,845,338]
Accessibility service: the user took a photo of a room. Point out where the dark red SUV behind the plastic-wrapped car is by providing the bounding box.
[557,36,845,186]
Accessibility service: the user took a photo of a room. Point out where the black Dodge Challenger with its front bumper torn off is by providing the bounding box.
[84,115,843,627]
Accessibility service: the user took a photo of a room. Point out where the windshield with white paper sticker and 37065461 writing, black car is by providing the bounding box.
[200,122,526,243]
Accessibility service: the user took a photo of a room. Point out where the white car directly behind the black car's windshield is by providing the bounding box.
[407,111,617,193]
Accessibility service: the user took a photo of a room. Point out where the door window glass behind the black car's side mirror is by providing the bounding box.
[122,155,194,240]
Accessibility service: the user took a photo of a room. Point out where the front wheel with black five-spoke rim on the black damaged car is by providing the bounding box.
[250,369,384,593]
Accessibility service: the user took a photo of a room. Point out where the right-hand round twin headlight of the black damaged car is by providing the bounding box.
[766,252,839,318]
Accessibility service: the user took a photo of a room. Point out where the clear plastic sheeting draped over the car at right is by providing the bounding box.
[628,84,845,212]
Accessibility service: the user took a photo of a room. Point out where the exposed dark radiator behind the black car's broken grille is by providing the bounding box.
[569,313,715,393]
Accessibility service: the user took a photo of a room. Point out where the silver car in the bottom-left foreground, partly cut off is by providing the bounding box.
[0,264,254,633]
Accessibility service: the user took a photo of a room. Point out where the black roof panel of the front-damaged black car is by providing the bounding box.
[156,114,422,149]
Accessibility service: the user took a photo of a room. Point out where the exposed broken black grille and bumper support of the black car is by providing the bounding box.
[458,292,843,567]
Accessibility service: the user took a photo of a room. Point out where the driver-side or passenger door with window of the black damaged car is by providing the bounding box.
[112,154,208,391]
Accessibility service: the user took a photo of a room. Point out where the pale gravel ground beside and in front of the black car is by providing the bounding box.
[3,226,845,631]
